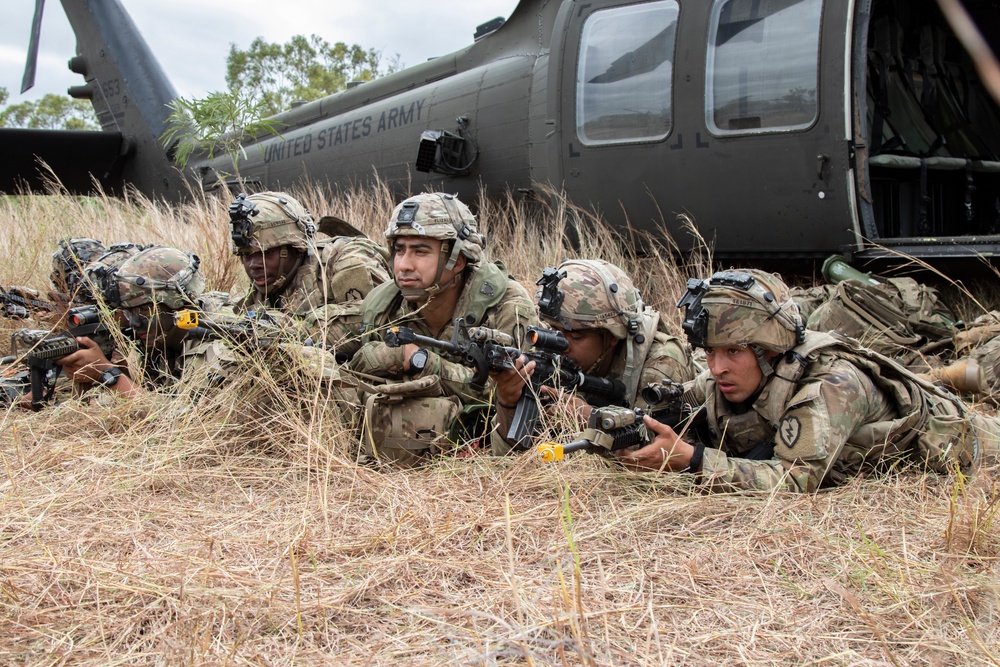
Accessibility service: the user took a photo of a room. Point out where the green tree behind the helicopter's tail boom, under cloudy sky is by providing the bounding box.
[226,35,400,115]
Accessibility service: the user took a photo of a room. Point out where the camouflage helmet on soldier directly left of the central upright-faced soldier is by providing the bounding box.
[229,192,316,254]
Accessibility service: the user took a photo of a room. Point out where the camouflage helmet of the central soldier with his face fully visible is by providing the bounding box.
[385,192,486,270]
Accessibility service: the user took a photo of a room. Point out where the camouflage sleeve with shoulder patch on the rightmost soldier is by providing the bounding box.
[701,359,893,492]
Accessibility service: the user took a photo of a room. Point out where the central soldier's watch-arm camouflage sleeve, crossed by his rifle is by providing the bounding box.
[424,280,538,403]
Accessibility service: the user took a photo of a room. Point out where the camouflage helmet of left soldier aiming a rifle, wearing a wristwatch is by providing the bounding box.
[104,246,205,310]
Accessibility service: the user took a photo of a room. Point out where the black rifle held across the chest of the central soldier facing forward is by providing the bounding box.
[385,318,522,391]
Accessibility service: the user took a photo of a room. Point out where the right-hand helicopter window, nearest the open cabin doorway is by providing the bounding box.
[706,0,823,135]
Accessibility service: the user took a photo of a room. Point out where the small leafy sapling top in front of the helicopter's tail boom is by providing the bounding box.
[161,90,278,173]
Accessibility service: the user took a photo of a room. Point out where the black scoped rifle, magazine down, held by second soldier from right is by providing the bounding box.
[507,327,625,451]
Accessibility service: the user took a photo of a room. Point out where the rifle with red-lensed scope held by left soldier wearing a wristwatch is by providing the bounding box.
[4,306,118,410]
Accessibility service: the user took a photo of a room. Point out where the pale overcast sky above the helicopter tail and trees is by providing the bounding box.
[0,0,518,104]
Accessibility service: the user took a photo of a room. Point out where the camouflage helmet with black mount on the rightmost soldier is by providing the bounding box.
[681,269,804,353]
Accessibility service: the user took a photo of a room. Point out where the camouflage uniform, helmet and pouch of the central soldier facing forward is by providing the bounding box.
[350,193,537,465]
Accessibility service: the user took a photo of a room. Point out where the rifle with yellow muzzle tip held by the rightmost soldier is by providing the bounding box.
[538,379,705,463]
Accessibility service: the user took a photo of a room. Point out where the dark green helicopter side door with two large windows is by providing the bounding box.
[552,0,858,257]
